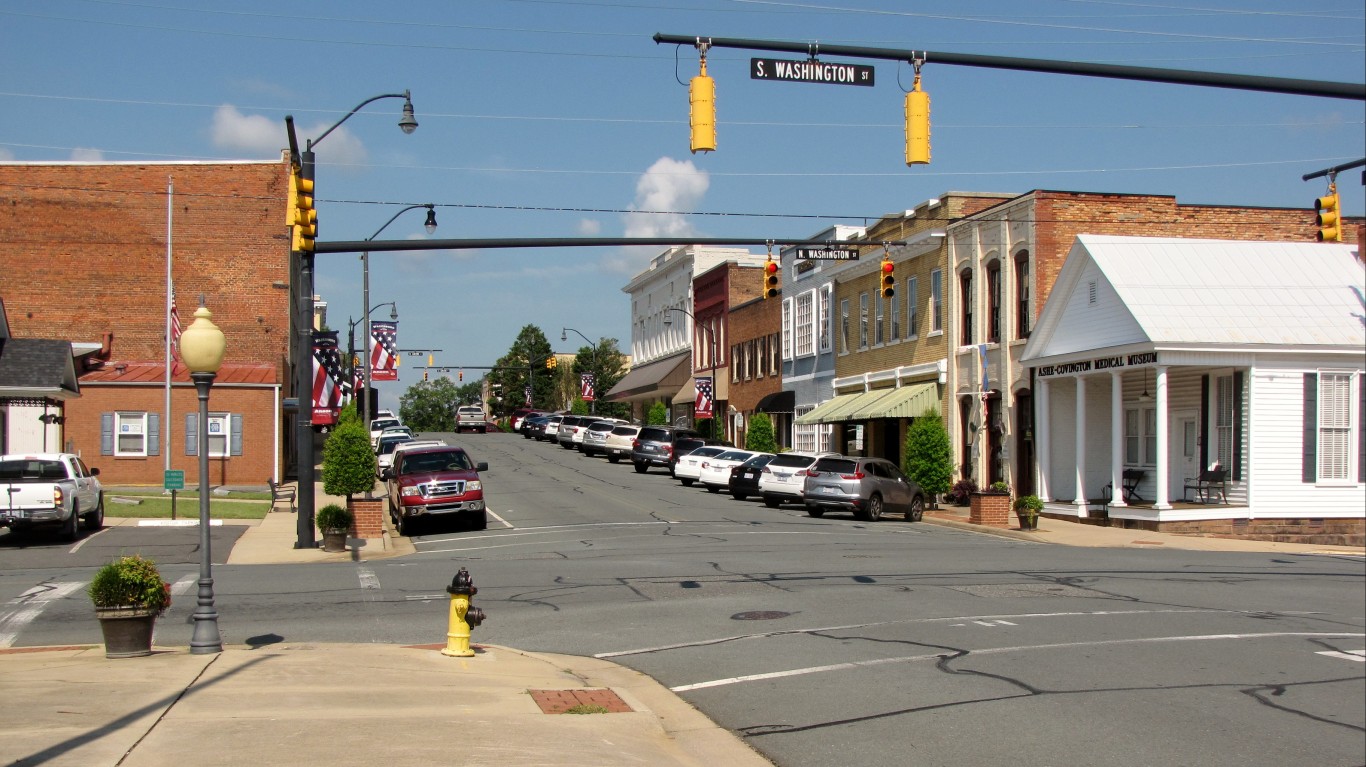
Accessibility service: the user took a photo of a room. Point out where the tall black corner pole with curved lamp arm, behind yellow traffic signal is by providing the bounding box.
[284,90,418,548]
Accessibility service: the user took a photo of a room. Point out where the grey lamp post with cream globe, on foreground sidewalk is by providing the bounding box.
[180,295,226,655]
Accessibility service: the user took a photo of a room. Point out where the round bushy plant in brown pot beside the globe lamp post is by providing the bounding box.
[86,554,171,658]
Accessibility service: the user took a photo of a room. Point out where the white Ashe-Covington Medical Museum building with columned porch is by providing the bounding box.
[1020,235,1366,535]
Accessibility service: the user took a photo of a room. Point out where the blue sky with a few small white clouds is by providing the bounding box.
[0,0,1366,406]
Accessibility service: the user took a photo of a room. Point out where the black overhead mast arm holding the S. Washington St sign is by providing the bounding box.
[654,33,1366,101]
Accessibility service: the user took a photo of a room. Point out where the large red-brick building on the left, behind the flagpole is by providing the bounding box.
[0,161,292,485]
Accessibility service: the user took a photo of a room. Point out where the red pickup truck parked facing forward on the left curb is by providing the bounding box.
[380,446,489,536]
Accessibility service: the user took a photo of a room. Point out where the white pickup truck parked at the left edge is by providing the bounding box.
[0,453,104,540]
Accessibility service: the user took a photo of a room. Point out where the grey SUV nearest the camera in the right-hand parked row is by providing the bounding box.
[803,455,925,522]
